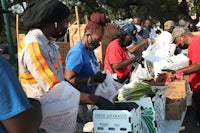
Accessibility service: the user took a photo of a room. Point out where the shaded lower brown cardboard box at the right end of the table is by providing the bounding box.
[165,99,186,120]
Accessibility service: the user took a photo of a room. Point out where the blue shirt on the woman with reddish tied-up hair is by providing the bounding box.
[65,41,100,93]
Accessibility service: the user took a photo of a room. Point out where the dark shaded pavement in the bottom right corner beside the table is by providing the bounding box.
[180,106,200,133]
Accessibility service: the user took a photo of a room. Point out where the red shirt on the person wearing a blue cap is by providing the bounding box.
[104,39,132,78]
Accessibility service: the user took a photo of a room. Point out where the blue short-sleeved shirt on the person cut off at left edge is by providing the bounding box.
[0,55,31,133]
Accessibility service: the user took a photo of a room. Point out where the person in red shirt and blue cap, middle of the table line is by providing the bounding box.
[104,24,141,83]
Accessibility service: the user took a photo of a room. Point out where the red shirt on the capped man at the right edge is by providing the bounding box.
[188,36,200,92]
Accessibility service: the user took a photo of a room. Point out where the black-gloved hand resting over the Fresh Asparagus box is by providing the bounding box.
[95,96,115,110]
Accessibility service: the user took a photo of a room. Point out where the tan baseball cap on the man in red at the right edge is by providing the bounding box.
[171,26,188,43]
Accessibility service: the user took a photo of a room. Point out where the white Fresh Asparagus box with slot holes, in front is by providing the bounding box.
[93,107,141,133]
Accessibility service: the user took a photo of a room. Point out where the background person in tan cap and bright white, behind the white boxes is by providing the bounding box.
[158,20,175,43]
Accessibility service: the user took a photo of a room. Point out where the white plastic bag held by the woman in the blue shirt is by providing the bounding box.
[95,72,122,99]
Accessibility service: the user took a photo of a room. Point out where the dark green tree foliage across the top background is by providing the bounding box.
[0,0,200,43]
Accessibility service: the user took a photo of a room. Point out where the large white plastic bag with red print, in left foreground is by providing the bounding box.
[40,81,80,133]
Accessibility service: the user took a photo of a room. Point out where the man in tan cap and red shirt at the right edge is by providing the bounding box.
[172,27,200,126]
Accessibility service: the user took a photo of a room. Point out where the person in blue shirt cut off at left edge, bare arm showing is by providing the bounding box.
[0,9,42,133]
